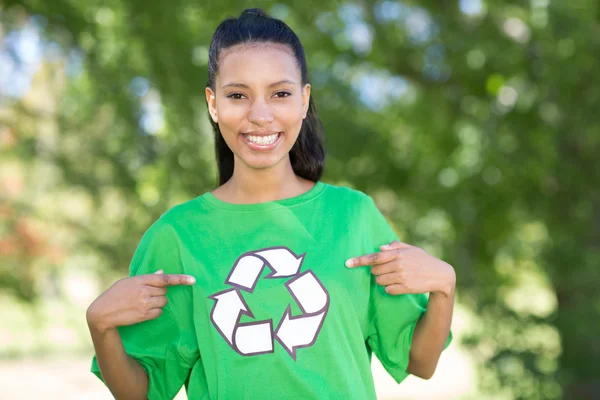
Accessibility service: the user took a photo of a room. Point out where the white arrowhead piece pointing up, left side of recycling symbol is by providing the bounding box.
[208,289,254,346]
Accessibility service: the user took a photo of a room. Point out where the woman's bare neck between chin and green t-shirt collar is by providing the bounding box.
[219,156,314,204]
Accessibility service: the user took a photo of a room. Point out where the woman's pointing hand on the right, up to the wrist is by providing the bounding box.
[346,241,456,296]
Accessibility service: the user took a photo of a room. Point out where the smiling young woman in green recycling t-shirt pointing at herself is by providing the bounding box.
[87,9,456,400]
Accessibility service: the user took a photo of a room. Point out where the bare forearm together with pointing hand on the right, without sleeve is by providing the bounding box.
[346,241,456,379]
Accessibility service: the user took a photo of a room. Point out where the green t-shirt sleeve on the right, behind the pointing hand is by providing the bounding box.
[362,196,452,383]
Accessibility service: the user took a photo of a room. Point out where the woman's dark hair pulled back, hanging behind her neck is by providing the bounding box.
[207,8,325,185]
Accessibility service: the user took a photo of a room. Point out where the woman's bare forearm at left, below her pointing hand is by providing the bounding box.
[90,325,148,400]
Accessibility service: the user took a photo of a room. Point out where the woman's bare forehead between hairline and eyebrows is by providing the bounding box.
[216,43,301,85]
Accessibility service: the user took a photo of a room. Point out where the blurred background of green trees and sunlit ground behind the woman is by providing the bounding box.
[0,0,600,400]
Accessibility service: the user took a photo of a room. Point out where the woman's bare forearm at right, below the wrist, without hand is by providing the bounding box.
[407,280,454,379]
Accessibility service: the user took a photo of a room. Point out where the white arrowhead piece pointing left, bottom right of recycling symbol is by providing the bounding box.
[275,306,327,361]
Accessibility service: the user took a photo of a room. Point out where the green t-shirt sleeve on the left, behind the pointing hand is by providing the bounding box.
[91,219,199,400]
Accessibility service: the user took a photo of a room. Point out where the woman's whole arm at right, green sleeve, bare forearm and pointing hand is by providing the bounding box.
[346,198,456,383]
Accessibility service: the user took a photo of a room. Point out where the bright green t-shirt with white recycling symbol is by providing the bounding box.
[92,182,452,400]
